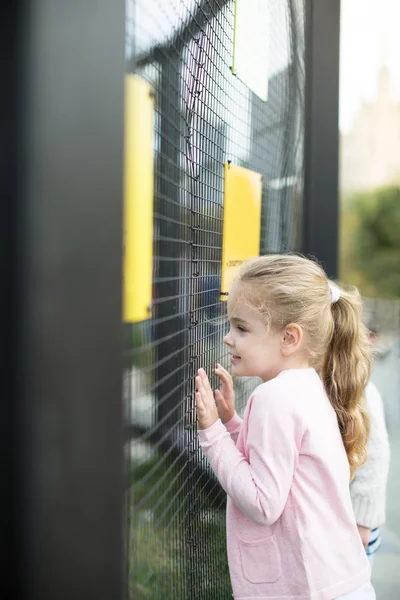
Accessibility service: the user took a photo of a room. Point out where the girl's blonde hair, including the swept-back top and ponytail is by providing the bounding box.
[237,254,371,478]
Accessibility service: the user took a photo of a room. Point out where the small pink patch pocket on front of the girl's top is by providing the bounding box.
[239,536,282,583]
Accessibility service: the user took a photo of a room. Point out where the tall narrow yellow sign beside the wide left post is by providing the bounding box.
[123,75,154,323]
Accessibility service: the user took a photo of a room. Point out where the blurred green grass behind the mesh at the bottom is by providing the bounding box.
[128,453,232,600]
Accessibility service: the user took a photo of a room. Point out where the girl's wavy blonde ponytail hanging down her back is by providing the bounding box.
[322,290,371,479]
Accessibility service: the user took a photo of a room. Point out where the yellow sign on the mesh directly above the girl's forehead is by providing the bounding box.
[221,163,262,300]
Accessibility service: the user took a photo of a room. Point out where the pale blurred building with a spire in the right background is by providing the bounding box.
[340,67,400,193]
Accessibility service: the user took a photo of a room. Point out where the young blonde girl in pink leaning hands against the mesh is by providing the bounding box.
[196,255,375,600]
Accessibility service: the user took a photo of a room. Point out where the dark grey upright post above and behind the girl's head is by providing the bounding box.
[302,0,340,277]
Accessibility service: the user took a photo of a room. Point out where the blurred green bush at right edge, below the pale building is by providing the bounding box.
[340,186,400,298]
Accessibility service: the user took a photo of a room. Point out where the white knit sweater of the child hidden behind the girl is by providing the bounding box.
[350,382,390,529]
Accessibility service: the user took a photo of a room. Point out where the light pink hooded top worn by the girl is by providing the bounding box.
[199,369,370,600]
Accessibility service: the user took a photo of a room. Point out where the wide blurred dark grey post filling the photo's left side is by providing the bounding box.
[0,0,125,600]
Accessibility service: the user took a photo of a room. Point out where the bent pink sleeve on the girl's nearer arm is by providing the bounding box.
[199,394,304,525]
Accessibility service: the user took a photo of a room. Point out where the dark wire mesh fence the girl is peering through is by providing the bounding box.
[124,0,306,600]
